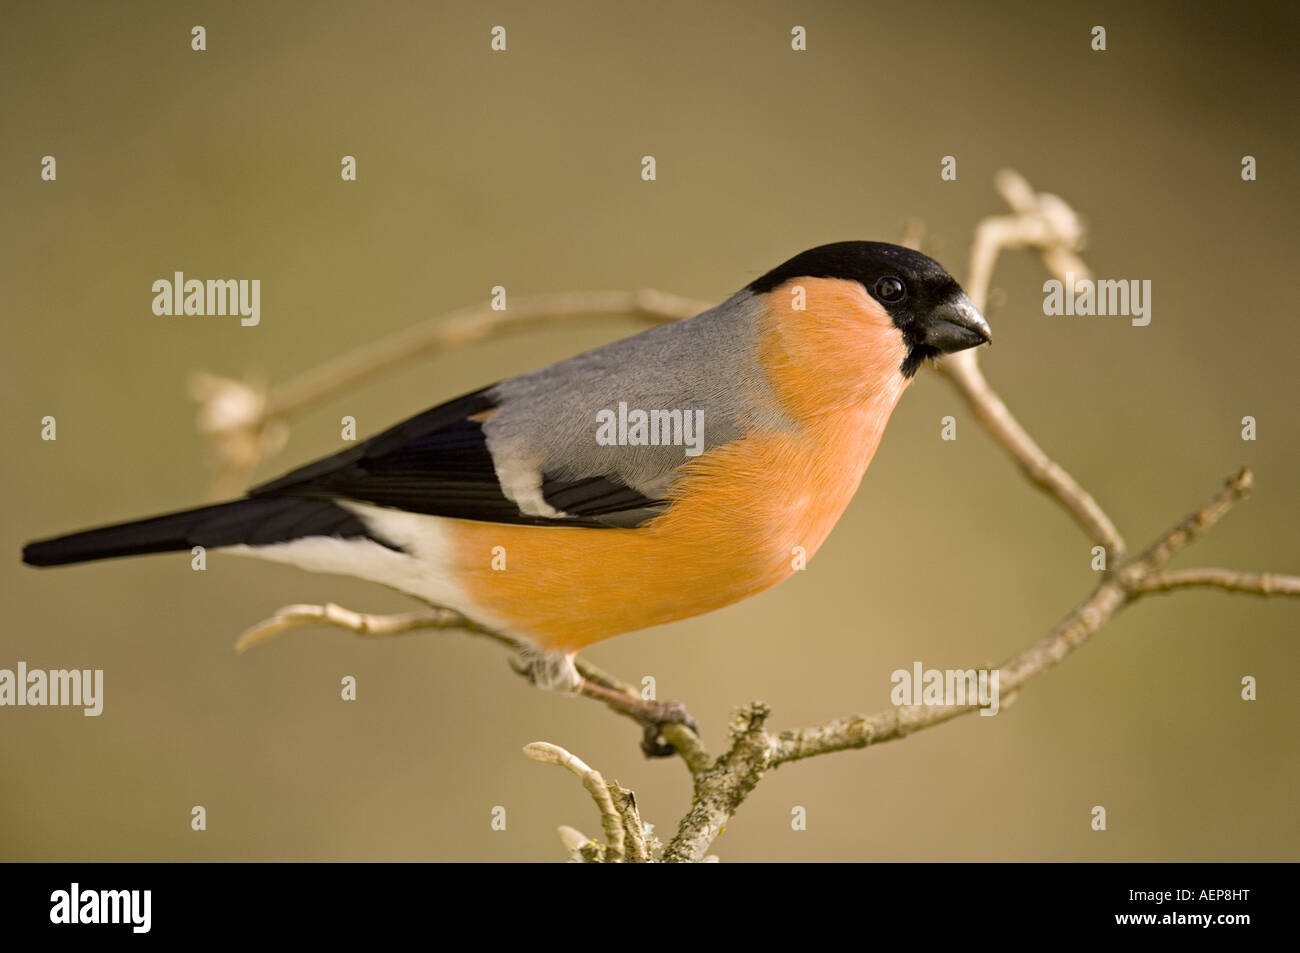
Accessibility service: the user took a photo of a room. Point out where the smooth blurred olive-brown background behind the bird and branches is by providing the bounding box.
[0,3,1300,861]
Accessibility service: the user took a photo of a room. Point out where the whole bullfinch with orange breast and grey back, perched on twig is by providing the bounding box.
[23,242,989,748]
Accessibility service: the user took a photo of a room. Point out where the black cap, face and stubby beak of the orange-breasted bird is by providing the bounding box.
[746,242,989,377]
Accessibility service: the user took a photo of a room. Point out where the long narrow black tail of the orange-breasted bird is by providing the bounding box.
[22,497,395,566]
